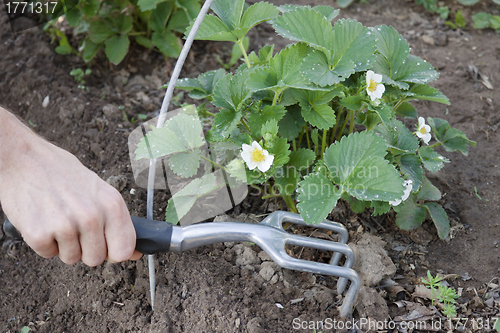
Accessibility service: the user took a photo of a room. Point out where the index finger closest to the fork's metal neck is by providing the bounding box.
[104,188,136,262]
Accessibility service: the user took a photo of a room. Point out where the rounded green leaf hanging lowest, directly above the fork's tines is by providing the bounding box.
[297,173,341,224]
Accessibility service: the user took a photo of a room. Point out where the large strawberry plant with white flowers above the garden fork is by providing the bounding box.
[136,0,475,239]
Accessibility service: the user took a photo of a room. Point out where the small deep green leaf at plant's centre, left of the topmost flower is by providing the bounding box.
[293,87,342,129]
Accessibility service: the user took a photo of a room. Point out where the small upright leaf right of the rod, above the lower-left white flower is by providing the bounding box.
[212,72,251,112]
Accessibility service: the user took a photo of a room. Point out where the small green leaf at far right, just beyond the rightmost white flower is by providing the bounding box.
[427,117,476,155]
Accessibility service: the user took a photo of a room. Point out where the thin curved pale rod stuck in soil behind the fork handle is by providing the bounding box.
[147,0,213,310]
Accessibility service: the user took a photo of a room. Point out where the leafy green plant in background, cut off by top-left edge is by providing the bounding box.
[45,0,200,64]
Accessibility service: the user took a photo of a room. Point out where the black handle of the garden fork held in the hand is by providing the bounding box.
[3,216,172,254]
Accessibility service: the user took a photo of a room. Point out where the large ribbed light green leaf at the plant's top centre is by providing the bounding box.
[273,7,334,59]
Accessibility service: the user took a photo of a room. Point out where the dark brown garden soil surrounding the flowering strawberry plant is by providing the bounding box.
[0,0,500,333]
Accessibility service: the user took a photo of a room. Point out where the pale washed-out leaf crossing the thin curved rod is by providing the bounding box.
[135,113,205,160]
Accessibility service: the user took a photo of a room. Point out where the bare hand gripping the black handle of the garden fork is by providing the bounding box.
[0,108,141,266]
